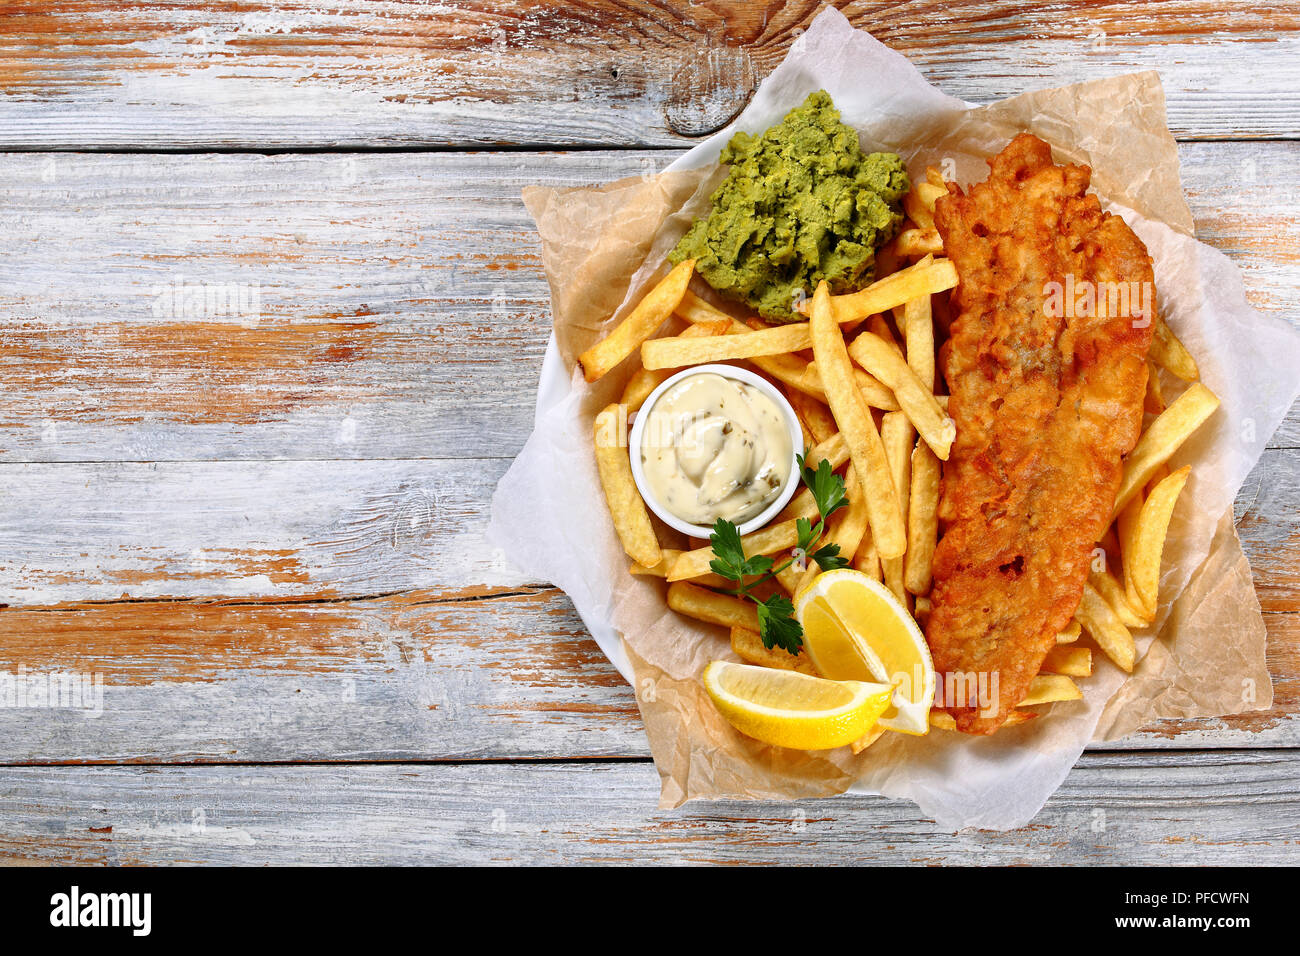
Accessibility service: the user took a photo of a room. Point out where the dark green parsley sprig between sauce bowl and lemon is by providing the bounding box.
[709,455,849,654]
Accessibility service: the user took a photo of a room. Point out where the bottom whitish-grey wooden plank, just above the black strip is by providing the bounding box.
[0,750,1300,865]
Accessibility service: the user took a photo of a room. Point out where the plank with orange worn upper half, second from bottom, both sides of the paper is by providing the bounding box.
[0,587,1300,765]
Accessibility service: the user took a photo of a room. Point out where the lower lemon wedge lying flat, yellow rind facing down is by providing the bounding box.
[705,661,892,750]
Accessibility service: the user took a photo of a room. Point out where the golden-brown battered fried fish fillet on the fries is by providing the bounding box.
[926,134,1154,734]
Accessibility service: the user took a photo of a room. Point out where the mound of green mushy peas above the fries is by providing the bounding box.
[668,90,909,323]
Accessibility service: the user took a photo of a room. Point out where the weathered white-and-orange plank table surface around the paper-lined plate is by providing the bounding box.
[0,0,1300,864]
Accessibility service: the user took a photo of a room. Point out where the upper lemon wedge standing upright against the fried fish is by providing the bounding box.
[794,568,935,735]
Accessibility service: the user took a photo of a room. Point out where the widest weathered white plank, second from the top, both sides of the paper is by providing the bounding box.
[0,143,1300,462]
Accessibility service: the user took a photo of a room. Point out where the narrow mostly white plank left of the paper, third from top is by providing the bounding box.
[0,459,521,606]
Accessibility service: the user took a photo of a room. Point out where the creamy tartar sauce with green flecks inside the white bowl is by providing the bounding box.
[641,372,792,525]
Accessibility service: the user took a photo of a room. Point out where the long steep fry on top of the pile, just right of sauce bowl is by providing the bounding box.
[810,280,907,558]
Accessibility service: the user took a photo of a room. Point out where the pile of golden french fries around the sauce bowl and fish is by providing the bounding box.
[580,169,1218,733]
